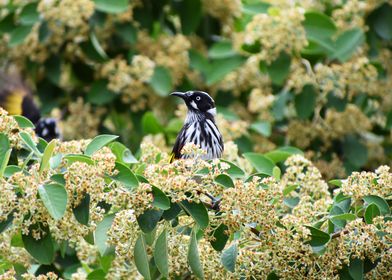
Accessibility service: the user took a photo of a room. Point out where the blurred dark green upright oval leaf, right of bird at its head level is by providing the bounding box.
[294,84,317,120]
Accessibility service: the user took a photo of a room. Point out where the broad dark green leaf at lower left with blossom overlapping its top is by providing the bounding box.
[22,224,55,264]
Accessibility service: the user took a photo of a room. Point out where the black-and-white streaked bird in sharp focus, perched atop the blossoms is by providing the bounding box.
[170,91,223,162]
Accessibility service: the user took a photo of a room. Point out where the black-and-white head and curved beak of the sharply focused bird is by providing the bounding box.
[171,90,216,116]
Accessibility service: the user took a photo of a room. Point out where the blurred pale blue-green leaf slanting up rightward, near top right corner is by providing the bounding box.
[331,27,365,62]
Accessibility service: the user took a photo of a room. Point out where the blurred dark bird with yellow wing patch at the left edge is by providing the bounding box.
[0,72,60,141]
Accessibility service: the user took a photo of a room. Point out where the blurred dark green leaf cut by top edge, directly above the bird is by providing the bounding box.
[178,0,202,35]
